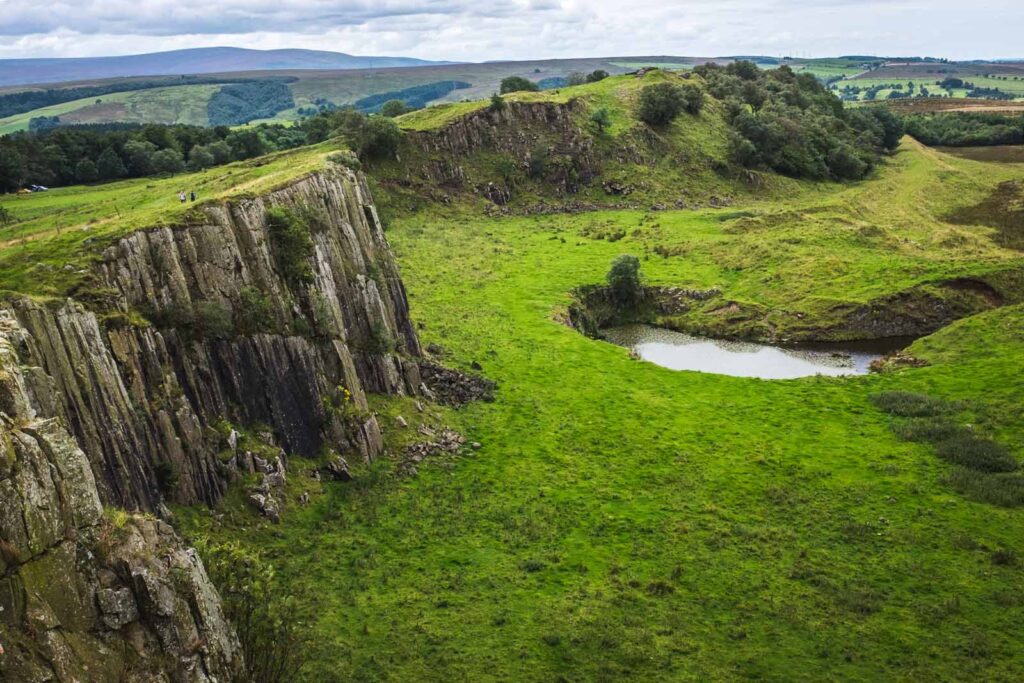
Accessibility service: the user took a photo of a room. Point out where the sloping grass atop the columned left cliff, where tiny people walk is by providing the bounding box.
[0,142,335,296]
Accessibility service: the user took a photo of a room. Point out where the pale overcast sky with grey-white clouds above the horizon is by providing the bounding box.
[0,0,1024,61]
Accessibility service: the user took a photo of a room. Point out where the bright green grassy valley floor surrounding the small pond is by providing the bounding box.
[180,137,1024,681]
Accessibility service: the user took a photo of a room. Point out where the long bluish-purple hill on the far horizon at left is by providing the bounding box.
[0,47,451,86]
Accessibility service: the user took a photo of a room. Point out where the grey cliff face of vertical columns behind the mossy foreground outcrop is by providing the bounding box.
[3,168,420,510]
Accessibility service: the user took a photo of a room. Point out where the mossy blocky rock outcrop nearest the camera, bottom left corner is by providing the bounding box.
[0,311,243,683]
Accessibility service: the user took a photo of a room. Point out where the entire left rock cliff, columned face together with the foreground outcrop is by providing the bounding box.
[0,165,425,683]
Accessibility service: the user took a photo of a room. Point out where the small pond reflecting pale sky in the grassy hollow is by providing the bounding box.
[601,325,912,380]
